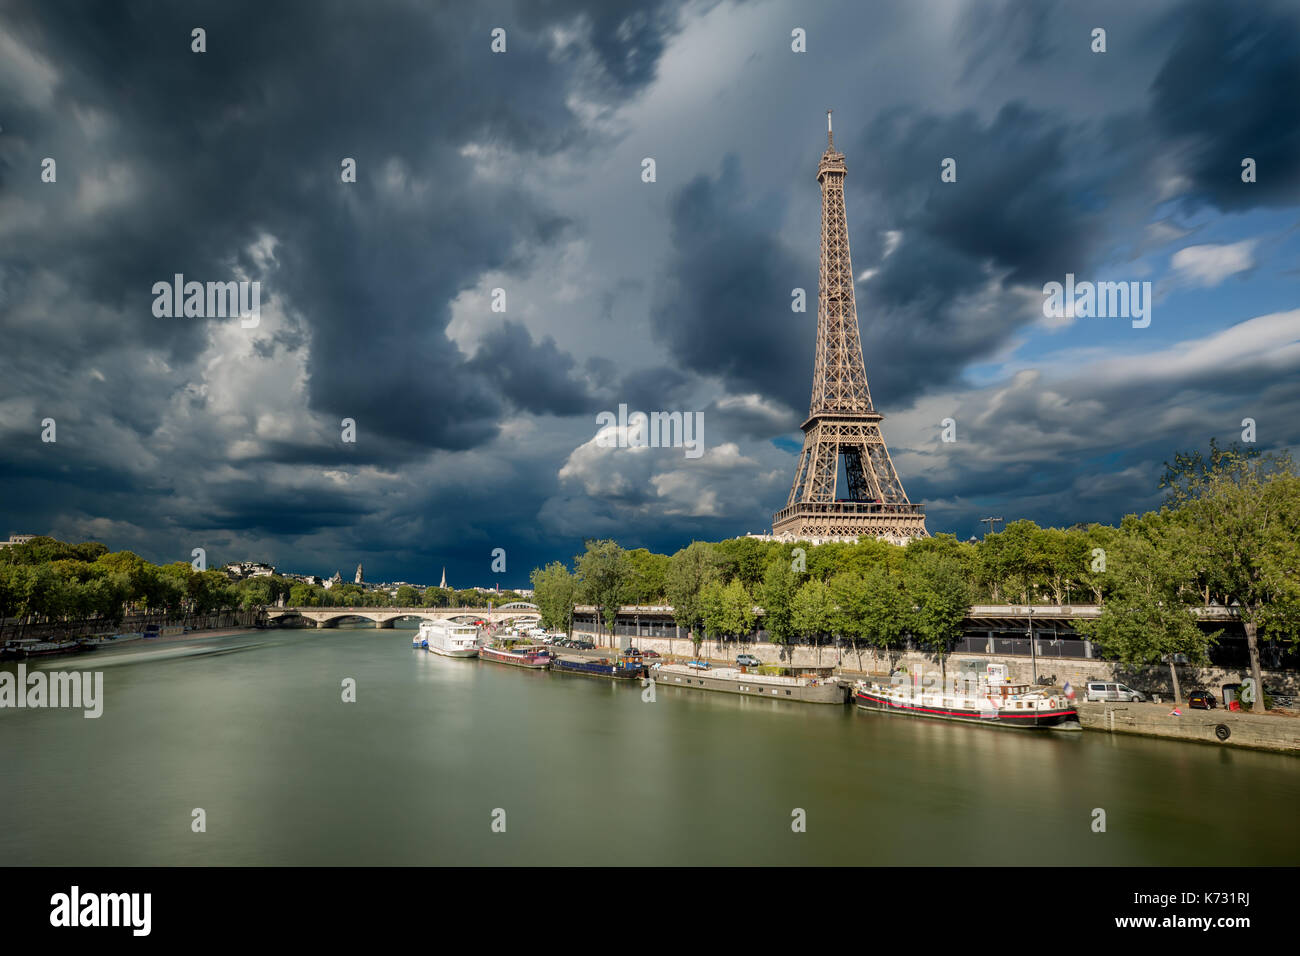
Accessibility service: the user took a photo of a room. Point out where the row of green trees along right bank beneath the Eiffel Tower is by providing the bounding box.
[532,441,1300,712]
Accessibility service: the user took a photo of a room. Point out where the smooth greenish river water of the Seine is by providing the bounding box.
[0,627,1300,866]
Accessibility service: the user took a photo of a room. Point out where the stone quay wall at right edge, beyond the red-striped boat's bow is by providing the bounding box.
[1076,701,1300,754]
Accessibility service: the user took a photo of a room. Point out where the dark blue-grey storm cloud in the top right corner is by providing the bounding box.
[1151,0,1300,211]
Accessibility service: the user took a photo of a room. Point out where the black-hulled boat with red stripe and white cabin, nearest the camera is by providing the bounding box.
[853,663,1082,730]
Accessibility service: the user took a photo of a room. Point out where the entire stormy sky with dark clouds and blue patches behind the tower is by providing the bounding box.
[0,0,1300,587]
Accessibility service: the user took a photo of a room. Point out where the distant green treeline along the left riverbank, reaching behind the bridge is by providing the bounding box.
[0,537,524,630]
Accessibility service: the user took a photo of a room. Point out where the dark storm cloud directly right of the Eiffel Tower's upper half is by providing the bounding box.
[850,104,1113,402]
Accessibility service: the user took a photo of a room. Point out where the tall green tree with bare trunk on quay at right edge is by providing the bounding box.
[1161,441,1300,713]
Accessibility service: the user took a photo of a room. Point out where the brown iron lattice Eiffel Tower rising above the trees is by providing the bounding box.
[772,109,930,544]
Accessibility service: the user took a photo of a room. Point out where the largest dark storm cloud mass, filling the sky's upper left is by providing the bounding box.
[0,3,691,567]
